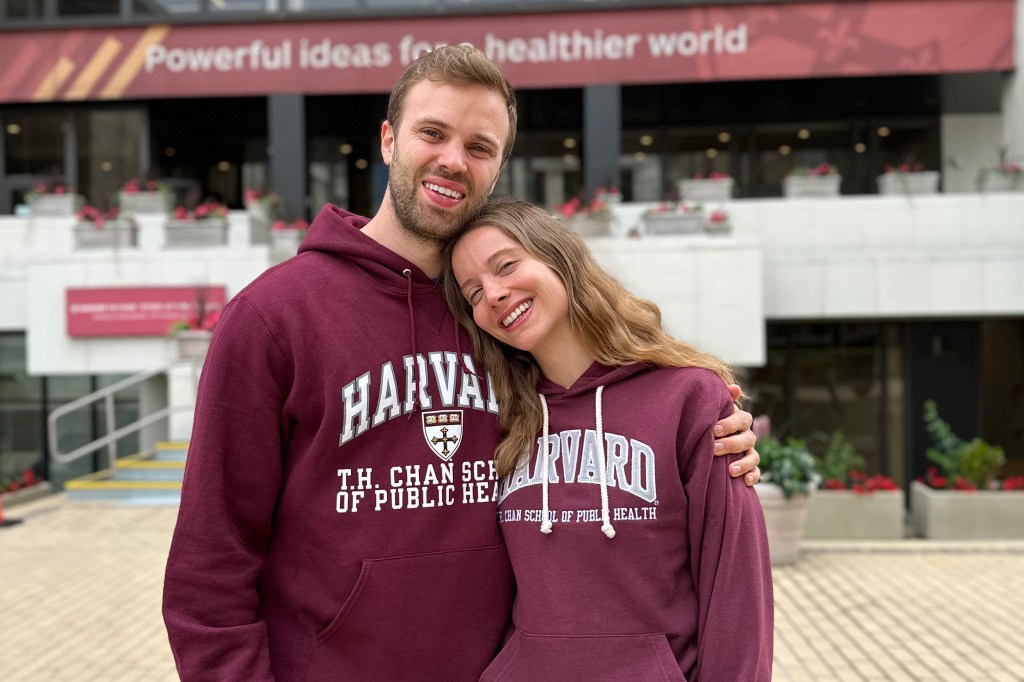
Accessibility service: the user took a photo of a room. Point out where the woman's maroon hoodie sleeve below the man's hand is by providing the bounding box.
[680,378,774,682]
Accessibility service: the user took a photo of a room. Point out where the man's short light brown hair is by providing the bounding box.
[387,45,517,165]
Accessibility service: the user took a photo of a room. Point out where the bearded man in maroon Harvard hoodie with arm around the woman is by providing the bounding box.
[164,46,758,682]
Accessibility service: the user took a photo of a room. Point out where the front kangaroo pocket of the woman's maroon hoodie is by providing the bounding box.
[480,630,686,682]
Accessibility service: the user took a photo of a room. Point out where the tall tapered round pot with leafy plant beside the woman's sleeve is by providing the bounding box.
[754,437,817,566]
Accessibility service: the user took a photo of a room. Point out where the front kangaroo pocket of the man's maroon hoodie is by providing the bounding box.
[306,545,512,681]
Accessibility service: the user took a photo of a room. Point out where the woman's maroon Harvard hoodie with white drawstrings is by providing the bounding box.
[480,363,773,682]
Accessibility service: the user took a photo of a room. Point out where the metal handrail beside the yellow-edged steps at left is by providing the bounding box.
[46,359,201,471]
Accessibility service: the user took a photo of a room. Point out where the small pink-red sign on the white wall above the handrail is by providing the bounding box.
[66,286,227,337]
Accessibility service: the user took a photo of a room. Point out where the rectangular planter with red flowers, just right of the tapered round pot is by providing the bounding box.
[804,431,904,540]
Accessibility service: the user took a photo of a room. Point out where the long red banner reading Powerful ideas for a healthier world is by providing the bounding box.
[0,0,1014,102]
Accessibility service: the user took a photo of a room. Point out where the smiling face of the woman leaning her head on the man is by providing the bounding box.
[452,225,575,364]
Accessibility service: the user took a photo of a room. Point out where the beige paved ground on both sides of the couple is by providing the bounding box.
[0,496,1024,682]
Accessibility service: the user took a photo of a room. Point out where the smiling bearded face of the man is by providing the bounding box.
[381,81,509,242]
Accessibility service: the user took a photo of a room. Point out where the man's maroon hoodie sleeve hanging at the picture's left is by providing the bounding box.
[164,297,290,681]
